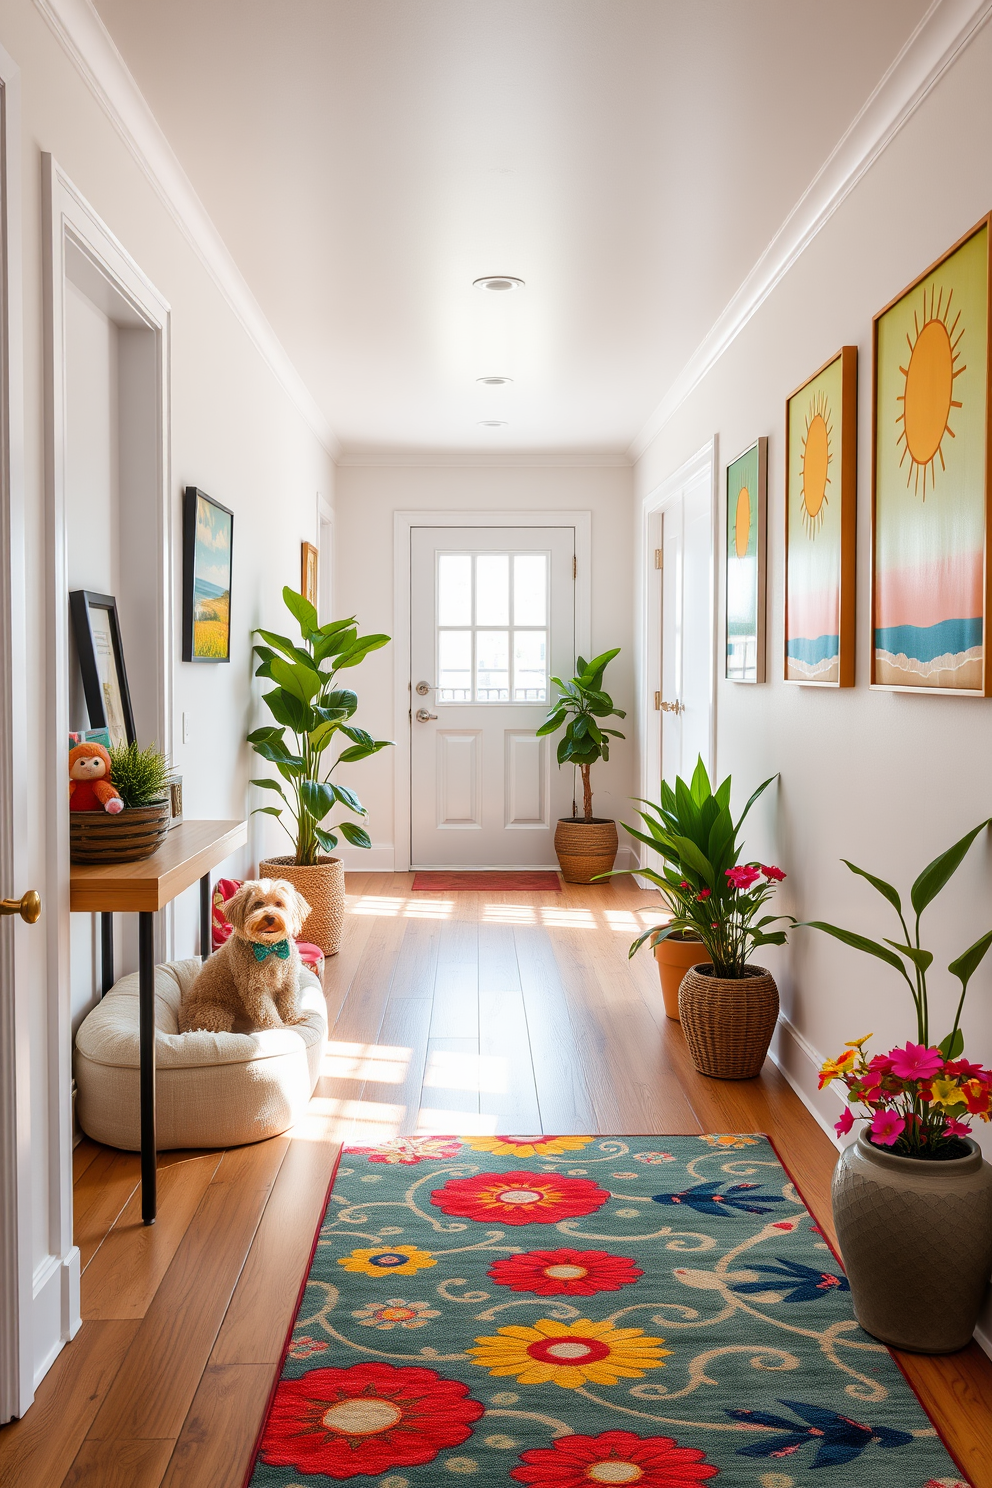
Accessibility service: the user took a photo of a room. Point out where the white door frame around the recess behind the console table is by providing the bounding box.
[33,155,175,1384]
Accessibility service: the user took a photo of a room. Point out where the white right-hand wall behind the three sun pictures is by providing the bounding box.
[637,17,992,1153]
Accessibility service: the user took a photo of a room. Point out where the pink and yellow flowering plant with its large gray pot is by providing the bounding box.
[809,821,992,1354]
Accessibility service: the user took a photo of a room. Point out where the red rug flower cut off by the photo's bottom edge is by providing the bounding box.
[510,1431,720,1488]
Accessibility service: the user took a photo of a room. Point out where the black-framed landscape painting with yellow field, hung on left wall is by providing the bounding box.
[183,485,233,661]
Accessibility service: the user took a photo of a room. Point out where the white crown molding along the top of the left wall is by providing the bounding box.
[34,0,342,460]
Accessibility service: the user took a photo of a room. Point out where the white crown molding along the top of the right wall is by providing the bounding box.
[628,0,992,460]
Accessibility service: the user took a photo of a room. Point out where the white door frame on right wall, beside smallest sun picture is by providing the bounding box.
[637,446,720,868]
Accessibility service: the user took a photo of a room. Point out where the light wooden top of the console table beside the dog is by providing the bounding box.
[68,821,248,914]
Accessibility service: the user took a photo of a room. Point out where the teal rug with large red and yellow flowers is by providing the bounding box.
[243,1135,968,1488]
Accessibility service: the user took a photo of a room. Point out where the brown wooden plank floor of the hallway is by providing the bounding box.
[0,873,992,1488]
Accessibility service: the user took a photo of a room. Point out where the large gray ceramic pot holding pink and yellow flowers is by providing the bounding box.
[833,1132,992,1354]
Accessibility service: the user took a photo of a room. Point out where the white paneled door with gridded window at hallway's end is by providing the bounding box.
[410,527,576,868]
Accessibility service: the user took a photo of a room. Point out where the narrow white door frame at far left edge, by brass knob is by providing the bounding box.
[0,46,31,1423]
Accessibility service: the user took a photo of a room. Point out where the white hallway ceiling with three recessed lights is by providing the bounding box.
[95,0,927,454]
